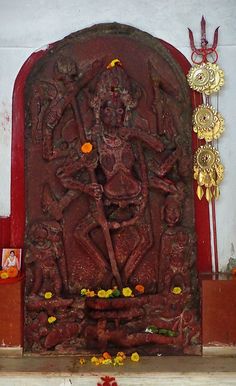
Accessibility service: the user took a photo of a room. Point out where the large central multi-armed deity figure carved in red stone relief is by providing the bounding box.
[39,62,183,287]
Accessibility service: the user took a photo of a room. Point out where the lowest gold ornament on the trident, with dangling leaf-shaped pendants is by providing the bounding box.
[194,144,224,201]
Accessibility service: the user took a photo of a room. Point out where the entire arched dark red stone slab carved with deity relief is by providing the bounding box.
[25,25,199,354]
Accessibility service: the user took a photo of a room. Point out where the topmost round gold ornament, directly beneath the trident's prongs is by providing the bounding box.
[187,62,224,95]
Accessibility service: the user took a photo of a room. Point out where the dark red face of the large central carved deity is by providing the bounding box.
[101,98,125,130]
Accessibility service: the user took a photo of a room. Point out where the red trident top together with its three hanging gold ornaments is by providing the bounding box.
[187,17,225,202]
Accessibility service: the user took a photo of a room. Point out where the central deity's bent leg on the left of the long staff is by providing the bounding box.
[74,214,111,271]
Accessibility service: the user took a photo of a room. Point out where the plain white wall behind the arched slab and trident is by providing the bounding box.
[0,0,236,268]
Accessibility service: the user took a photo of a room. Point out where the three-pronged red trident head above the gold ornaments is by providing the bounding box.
[188,16,220,64]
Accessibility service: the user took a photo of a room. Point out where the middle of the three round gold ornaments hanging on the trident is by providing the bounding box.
[193,104,225,142]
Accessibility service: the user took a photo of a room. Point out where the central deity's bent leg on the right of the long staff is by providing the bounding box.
[123,224,153,285]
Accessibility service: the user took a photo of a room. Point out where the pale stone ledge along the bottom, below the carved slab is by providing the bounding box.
[0,357,236,386]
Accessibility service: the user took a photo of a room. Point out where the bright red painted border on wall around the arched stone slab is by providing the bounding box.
[0,40,212,272]
